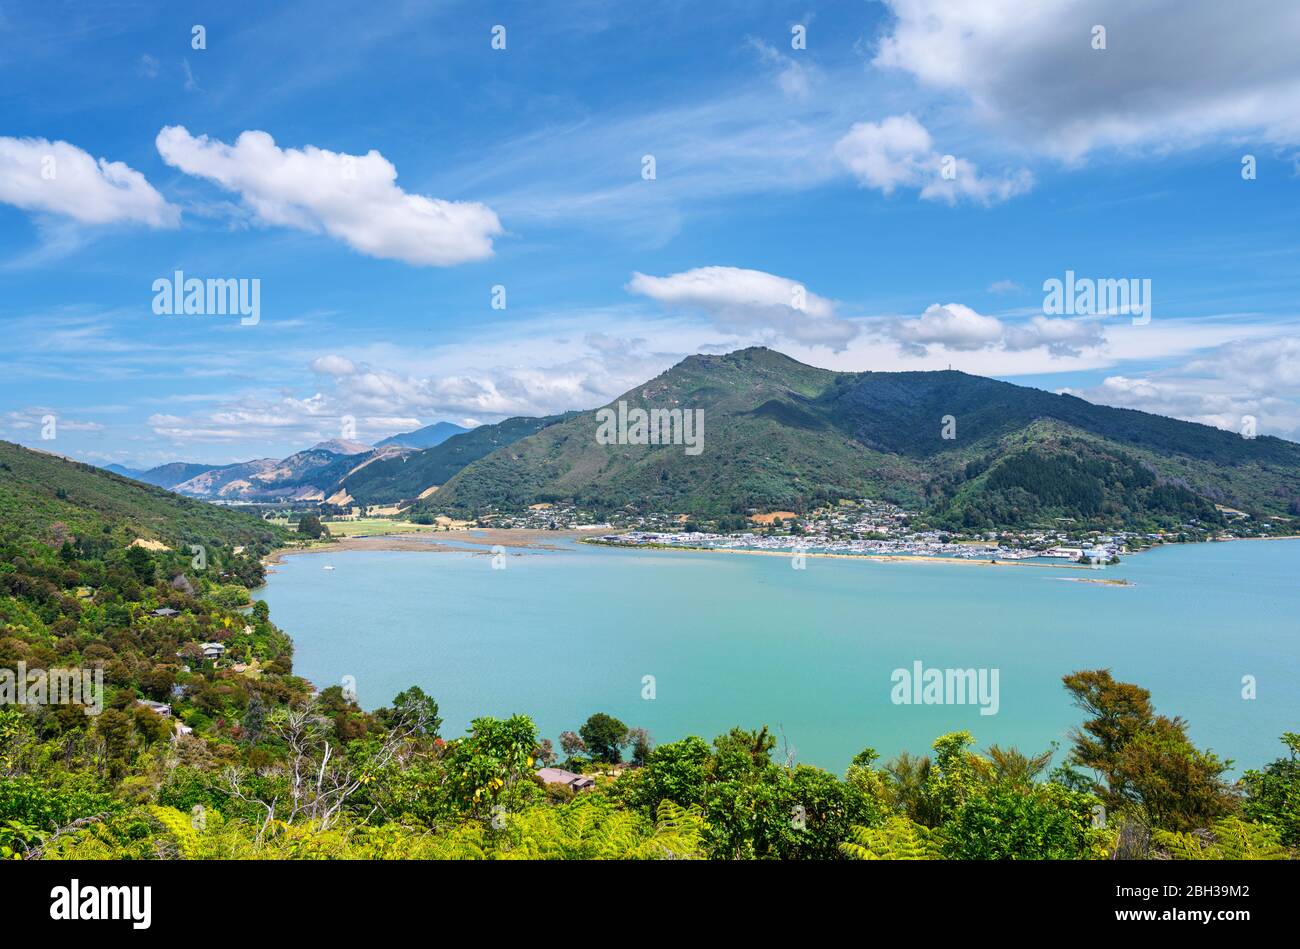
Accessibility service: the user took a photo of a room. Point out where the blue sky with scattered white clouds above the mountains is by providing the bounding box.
[0,0,1300,467]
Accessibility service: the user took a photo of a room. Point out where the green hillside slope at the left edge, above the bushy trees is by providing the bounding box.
[0,442,285,556]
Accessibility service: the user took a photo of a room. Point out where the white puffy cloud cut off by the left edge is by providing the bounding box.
[0,137,181,228]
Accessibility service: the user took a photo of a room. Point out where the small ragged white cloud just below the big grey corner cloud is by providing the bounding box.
[835,114,1034,205]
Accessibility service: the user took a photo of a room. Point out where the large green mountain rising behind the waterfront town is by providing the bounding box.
[417,348,1300,528]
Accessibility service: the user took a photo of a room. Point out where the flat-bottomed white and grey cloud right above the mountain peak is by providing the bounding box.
[627,267,858,350]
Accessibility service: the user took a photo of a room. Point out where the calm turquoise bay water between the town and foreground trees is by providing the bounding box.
[261,541,1300,771]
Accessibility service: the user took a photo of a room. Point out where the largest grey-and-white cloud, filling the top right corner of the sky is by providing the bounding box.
[875,0,1300,160]
